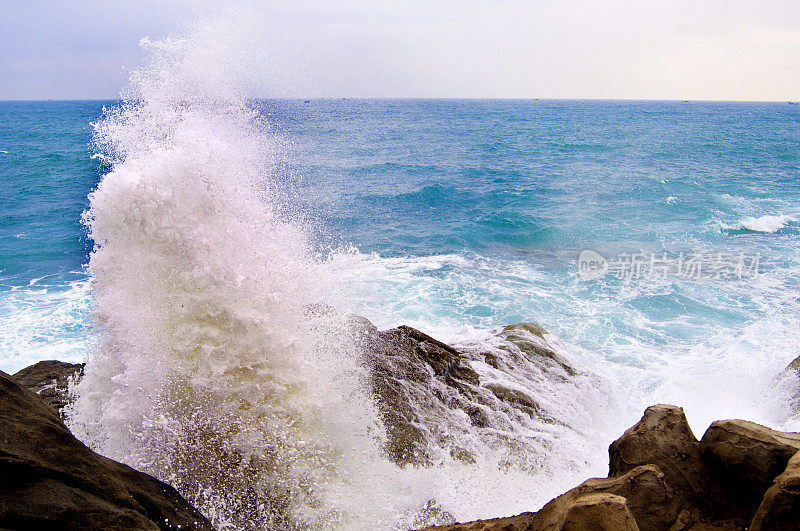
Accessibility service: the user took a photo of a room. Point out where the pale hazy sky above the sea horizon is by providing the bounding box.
[0,0,800,101]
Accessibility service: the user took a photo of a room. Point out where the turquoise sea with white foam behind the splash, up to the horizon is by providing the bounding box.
[0,100,800,432]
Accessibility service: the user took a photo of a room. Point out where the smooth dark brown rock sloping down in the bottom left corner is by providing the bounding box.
[0,371,212,530]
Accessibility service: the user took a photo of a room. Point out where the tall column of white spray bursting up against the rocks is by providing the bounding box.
[67,16,406,529]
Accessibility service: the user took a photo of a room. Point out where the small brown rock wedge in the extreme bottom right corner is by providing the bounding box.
[749,454,800,531]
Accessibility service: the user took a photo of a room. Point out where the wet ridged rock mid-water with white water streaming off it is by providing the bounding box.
[360,318,594,466]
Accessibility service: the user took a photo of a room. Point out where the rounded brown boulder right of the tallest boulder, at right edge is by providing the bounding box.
[700,420,800,520]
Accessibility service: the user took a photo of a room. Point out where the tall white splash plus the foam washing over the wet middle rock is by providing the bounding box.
[70,13,620,529]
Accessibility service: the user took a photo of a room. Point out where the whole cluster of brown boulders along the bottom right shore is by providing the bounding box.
[426,404,800,531]
